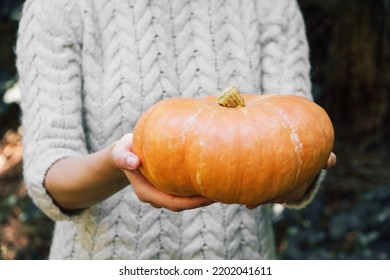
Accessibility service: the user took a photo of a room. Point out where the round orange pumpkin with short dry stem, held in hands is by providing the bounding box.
[132,87,334,205]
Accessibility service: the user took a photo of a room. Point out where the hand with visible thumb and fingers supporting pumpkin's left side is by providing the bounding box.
[112,134,214,212]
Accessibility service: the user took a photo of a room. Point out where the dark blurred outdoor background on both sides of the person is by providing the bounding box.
[0,0,390,259]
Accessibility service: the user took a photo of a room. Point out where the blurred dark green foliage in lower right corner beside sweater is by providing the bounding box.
[274,184,390,259]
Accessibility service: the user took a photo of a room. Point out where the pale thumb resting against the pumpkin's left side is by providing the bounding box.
[112,133,141,170]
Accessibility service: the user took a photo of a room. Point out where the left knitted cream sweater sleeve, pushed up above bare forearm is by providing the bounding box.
[16,0,87,220]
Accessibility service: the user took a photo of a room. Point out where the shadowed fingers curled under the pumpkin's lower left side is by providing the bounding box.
[125,171,214,212]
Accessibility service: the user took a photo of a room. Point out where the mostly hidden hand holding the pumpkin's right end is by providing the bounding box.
[246,153,337,209]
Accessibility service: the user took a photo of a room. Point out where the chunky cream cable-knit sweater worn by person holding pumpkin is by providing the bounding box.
[17,0,311,259]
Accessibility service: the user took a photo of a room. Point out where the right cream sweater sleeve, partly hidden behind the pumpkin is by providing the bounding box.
[258,0,326,208]
